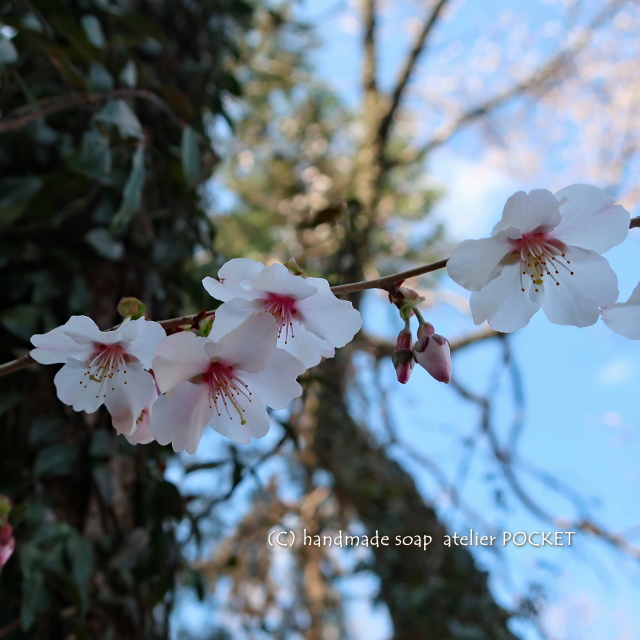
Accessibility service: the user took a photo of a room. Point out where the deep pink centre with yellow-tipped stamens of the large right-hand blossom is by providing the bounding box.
[511,231,574,291]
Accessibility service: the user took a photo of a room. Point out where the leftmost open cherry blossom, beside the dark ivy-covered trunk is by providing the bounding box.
[31,316,166,435]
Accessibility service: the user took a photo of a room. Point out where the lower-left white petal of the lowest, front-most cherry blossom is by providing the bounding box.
[149,382,214,455]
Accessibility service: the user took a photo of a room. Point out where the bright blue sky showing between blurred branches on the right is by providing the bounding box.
[294,0,640,640]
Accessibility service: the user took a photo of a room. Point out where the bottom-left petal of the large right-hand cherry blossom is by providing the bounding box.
[469,263,540,333]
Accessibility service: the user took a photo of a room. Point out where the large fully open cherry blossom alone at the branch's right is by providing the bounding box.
[447,184,630,332]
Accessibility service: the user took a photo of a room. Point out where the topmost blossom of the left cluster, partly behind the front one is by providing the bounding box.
[202,258,362,367]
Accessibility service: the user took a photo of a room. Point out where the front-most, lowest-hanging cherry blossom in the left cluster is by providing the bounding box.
[151,313,305,454]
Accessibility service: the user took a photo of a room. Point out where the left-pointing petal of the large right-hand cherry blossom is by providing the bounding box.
[447,234,513,291]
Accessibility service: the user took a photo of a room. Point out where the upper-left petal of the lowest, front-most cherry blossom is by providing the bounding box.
[153,331,209,392]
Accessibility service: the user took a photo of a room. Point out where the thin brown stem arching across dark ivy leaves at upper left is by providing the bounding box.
[0,88,185,135]
